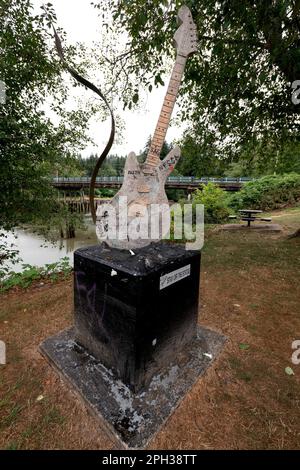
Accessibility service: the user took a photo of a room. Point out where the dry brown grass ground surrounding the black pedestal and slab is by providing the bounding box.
[0,208,300,449]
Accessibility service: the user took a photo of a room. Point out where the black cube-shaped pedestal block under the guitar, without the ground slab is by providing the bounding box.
[74,243,200,391]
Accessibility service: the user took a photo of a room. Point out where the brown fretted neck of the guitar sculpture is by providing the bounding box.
[145,55,187,166]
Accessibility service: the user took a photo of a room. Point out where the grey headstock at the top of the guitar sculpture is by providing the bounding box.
[174,6,197,57]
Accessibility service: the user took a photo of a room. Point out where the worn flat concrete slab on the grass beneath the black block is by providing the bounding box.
[40,327,226,449]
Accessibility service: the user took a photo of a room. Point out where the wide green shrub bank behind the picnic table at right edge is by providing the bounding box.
[229,173,300,210]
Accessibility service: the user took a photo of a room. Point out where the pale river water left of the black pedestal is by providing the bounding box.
[6,216,98,272]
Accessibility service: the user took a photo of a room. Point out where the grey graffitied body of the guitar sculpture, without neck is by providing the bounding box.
[96,147,180,250]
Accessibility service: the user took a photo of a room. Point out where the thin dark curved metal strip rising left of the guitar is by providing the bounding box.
[52,25,115,223]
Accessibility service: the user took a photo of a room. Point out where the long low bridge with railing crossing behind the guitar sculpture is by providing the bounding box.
[52,176,254,191]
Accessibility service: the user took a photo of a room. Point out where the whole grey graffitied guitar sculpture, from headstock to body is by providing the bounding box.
[96,6,197,250]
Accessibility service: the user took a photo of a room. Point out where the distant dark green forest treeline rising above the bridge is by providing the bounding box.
[73,135,300,177]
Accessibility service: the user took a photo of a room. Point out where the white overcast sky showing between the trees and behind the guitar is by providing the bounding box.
[32,0,183,156]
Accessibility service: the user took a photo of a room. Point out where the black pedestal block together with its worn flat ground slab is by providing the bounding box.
[40,243,225,448]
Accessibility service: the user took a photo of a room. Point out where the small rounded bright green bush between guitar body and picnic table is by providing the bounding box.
[193,183,230,224]
